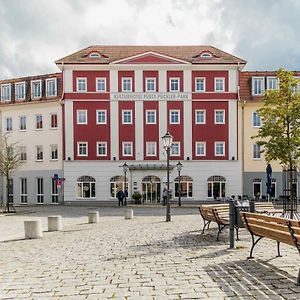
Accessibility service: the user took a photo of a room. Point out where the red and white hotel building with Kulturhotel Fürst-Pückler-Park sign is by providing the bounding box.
[56,46,246,203]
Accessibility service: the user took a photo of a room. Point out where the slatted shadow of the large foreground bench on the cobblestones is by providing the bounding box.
[204,260,300,299]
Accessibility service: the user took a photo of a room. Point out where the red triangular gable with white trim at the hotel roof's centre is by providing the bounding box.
[113,51,189,64]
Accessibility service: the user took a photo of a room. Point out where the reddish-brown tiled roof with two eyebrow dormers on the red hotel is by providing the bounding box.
[55,45,246,64]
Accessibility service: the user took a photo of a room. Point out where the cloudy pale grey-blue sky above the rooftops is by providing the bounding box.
[0,0,300,79]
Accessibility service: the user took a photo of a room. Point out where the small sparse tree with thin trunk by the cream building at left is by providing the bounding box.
[0,134,21,212]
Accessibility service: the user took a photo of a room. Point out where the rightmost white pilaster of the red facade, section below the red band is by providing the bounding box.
[228,100,237,160]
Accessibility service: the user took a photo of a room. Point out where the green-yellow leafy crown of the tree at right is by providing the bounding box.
[252,69,300,167]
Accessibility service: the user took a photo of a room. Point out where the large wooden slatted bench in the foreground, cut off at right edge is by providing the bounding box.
[241,212,300,285]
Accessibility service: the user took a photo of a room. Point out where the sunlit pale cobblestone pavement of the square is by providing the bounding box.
[0,207,300,299]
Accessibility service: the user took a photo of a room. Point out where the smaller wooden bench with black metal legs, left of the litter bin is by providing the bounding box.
[199,204,229,241]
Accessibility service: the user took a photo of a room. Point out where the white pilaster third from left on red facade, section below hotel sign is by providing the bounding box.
[135,101,144,160]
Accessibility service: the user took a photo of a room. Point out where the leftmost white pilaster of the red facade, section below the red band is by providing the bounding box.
[64,100,76,160]
